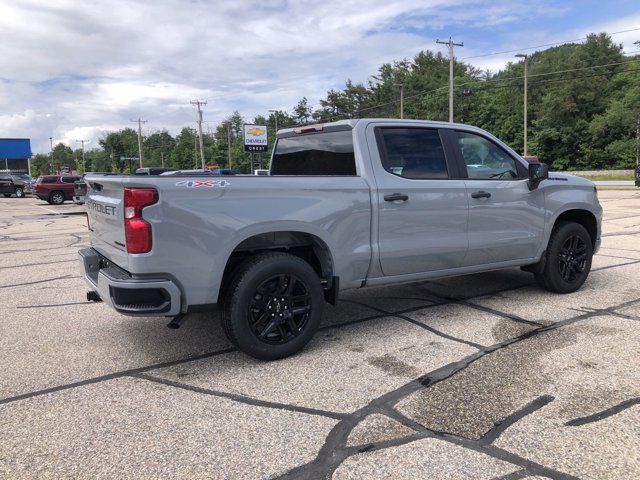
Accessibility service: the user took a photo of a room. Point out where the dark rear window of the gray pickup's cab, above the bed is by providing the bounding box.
[271,130,356,176]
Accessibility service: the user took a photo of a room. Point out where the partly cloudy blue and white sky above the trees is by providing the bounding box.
[0,0,640,152]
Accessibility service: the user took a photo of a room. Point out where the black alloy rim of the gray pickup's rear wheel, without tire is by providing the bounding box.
[248,274,313,345]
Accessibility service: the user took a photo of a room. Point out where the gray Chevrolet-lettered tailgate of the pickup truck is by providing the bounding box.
[85,177,128,269]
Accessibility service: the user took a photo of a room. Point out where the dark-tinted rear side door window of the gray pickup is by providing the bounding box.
[378,127,449,180]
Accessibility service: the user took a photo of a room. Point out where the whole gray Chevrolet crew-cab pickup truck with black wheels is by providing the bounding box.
[79,119,602,359]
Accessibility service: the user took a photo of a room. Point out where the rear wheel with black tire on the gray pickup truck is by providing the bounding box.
[222,252,324,360]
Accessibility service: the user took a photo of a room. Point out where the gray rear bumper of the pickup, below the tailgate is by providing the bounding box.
[78,248,182,317]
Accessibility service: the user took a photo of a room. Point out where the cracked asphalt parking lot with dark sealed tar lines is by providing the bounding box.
[0,189,640,479]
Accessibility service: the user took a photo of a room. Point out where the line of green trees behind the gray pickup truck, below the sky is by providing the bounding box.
[32,33,640,174]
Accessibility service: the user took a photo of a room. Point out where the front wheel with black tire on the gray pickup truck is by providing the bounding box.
[535,222,593,293]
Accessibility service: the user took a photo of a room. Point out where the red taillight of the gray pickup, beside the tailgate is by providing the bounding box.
[124,188,158,253]
